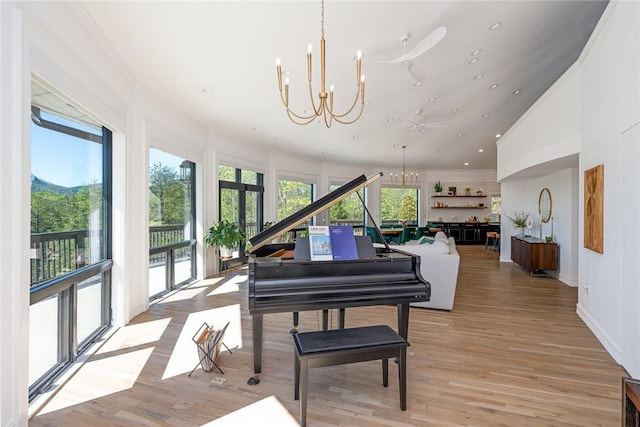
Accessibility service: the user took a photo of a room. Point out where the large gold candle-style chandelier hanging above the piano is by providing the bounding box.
[276,0,364,128]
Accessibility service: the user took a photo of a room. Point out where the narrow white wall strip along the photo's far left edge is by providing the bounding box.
[0,2,30,426]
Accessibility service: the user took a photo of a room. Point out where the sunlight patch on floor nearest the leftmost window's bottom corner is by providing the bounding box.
[40,347,154,414]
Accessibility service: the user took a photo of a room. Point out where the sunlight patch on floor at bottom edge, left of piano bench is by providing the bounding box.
[201,396,300,427]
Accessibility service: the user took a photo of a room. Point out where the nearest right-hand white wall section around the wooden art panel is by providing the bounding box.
[578,2,640,377]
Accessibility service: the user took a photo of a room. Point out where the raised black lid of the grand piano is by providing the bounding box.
[248,172,382,253]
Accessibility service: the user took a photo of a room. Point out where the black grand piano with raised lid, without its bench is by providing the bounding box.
[247,173,431,385]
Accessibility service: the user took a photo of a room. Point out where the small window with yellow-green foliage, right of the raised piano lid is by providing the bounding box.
[380,187,420,226]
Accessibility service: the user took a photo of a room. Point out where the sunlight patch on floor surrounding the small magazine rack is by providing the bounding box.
[162,304,242,379]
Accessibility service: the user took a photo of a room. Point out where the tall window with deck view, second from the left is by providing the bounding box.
[149,148,196,299]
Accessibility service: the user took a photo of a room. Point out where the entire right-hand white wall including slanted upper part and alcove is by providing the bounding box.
[498,1,640,377]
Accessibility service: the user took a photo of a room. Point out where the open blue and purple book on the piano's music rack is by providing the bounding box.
[309,225,358,261]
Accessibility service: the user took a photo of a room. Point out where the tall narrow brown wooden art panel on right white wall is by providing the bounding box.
[584,165,604,254]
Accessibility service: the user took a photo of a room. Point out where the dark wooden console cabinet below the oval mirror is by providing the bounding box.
[511,236,558,274]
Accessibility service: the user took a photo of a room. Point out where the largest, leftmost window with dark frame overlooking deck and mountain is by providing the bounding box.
[29,76,112,400]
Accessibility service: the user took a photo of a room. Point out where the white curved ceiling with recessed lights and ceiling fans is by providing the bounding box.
[79,0,606,169]
